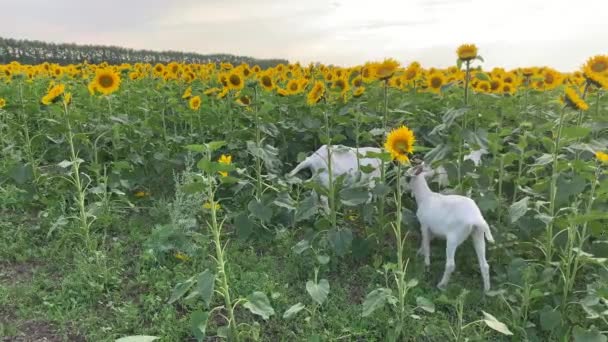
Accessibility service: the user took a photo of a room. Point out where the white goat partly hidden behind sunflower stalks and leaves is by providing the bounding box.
[289,145,382,209]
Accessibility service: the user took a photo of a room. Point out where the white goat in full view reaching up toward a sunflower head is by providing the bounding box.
[408,163,494,292]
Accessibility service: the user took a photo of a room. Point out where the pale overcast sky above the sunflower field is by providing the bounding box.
[0,0,608,71]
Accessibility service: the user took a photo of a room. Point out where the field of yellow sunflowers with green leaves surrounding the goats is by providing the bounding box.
[0,44,608,342]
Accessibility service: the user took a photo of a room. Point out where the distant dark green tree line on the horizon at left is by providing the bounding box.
[0,37,288,68]
